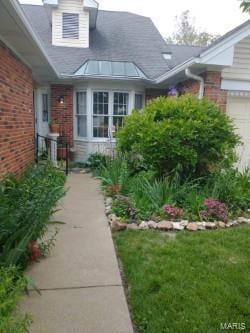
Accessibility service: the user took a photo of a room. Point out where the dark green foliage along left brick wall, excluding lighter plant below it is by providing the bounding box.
[0,163,65,266]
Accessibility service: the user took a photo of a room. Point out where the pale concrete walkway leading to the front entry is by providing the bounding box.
[21,174,133,333]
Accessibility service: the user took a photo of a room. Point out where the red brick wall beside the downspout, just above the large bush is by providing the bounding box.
[180,72,227,111]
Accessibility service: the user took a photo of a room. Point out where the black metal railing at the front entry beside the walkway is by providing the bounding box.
[36,134,69,175]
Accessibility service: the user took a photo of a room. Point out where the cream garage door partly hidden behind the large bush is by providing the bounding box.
[227,97,250,169]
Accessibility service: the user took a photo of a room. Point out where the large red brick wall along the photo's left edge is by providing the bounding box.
[0,41,34,179]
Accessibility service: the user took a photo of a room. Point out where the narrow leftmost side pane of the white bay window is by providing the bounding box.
[76,91,87,138]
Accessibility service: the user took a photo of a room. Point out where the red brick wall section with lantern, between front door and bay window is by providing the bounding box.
[51,85,73,147]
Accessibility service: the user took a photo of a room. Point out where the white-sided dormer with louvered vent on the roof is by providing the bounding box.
[43,0,98,48]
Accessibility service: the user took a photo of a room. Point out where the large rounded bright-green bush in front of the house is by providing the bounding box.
[117,95,239,177]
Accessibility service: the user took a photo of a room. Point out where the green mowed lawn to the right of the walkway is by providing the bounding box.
[114,226,250,333]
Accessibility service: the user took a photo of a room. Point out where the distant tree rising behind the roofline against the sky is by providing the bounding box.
[166,10,219,46]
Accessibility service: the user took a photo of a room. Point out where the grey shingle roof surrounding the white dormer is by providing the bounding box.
[22,5,174,79]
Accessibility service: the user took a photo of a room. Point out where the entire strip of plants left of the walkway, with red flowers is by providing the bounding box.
[0,163,65,333]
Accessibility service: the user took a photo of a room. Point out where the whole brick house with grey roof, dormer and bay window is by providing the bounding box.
[0,0,250,178]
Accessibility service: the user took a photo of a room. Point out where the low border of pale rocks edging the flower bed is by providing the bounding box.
[105,197,250,232]
